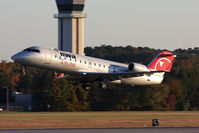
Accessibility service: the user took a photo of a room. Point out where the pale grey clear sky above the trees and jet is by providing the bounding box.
[0,0,199,61]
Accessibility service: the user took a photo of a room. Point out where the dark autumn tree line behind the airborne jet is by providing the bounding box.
[0,45,199,111]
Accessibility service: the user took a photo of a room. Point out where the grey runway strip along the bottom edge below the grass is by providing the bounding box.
[0,127,199,133]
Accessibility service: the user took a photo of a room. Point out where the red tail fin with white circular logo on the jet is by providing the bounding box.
[147,51,176,72]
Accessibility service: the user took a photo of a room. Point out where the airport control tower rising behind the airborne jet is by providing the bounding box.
[54,0,86,55]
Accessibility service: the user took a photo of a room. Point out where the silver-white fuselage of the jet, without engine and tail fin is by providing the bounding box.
[12,47,164,85]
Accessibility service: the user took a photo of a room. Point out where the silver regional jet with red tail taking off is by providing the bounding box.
[11,46,175,88]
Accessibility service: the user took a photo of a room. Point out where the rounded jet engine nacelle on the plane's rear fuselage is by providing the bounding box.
[128,62,149,72]
